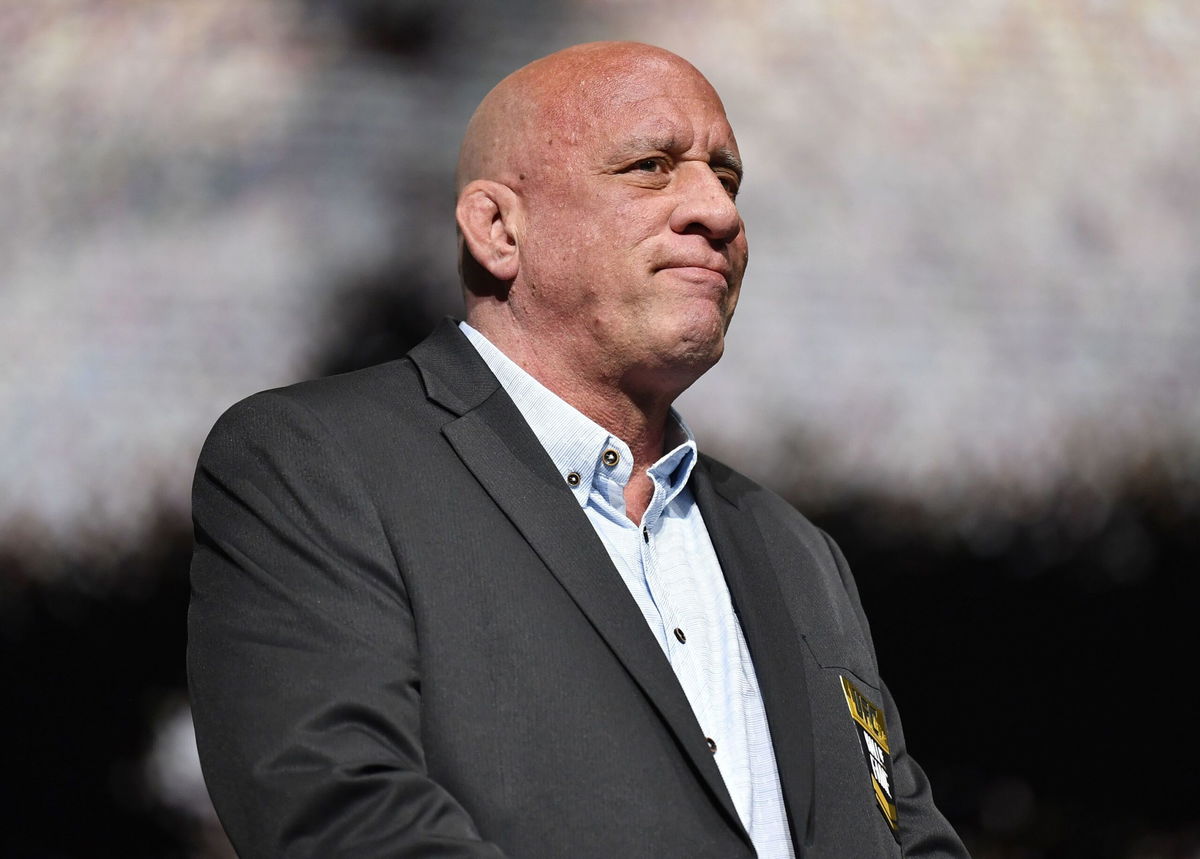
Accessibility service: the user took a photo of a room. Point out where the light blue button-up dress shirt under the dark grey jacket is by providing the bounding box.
[460,323,793,859]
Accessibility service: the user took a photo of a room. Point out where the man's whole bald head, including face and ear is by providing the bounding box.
[456,42,748,403]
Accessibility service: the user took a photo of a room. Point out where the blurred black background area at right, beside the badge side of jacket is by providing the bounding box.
[816,477,1200,858]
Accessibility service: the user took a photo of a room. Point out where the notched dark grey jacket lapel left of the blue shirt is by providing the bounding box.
[409,322,749,843]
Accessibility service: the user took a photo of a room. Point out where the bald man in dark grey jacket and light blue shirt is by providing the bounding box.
[188,43,965,859]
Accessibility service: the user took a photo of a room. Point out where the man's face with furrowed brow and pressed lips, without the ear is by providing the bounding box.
[512,61,748,390]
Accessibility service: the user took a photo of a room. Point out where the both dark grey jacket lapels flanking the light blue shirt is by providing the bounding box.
[409,319,814,855]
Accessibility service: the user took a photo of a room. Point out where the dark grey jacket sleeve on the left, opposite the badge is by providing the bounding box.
[187,392,502,859]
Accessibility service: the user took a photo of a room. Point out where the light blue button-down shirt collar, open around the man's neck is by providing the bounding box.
[458,322,696,509]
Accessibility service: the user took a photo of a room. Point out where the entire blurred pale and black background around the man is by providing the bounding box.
[0,0,1200,859]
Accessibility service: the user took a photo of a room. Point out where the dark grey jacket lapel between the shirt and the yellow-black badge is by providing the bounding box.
[691,457,815,855]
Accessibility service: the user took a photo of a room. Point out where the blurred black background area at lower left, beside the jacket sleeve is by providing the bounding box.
[0,522,204,858]
